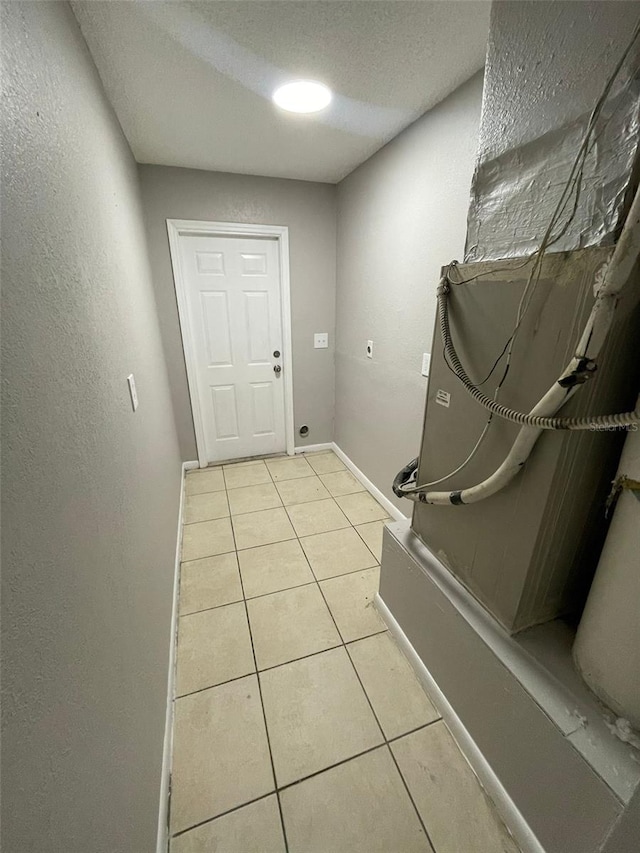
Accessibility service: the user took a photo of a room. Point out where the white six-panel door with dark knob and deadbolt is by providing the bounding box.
[179,235,286,462]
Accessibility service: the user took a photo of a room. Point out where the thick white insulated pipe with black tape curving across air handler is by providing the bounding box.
[406,188,640,505]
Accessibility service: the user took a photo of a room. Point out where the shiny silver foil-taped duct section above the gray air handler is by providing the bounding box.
[467,0,640,261]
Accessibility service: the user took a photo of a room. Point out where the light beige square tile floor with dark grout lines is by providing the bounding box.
[170,452,517,853]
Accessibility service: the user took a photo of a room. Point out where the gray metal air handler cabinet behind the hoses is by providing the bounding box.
[413,248,640,631]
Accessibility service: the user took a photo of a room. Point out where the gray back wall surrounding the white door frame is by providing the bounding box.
[139,166,336,460]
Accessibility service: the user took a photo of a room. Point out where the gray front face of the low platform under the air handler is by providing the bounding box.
[380,529,622,853]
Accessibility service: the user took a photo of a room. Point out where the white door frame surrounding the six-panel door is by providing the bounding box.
[167,219,295,468]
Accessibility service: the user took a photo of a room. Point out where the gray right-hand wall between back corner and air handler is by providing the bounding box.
[335,74,482,515]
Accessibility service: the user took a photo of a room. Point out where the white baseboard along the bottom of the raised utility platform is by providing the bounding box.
[374,593,545,853]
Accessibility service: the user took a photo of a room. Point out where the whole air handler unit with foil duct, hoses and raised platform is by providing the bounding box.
[379,2,640,853]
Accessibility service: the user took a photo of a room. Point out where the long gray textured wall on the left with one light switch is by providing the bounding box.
[2,3,180,853]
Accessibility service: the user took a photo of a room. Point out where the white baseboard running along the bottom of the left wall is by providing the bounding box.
[156,460,192,853]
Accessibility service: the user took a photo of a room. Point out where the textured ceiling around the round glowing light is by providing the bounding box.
[72,0,490,182]
